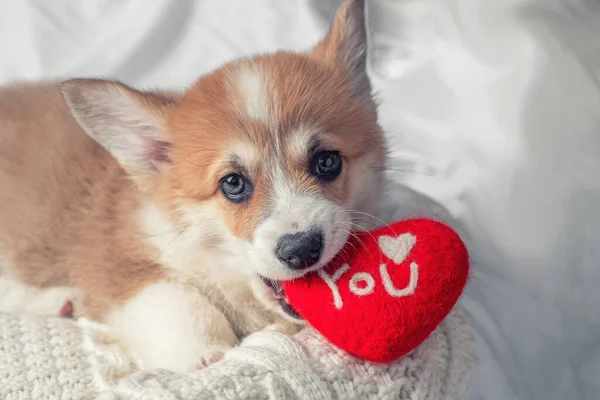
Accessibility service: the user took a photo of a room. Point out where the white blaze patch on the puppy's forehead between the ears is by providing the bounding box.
[236,67,269,121]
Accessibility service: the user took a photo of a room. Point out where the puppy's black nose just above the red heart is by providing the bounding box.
[275,232,323,269]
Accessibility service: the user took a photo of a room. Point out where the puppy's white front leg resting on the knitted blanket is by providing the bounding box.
[107,281,237,372]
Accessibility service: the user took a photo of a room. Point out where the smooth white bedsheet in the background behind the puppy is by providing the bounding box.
[0,0,600,400]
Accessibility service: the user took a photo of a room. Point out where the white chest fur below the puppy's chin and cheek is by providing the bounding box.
[140,202,273,334]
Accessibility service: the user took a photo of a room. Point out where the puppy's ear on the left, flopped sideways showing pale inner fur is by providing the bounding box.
[60,79,175,178]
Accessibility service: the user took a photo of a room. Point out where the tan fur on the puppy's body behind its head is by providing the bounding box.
[0,83,164,318]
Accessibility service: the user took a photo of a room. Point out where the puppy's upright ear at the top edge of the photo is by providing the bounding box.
[312,0,371,96]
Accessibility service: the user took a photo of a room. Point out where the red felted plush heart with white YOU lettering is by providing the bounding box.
[284,219,469,363]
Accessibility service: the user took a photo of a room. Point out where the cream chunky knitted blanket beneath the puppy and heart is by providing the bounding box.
[0,309,475,400]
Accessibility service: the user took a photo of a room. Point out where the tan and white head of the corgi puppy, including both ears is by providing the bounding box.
[62,0,384,280]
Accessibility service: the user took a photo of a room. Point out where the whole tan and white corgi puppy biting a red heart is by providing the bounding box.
[0,0,385,372]
